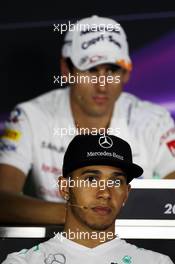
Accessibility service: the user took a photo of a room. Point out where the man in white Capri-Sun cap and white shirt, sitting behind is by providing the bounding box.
[0,16,175,224]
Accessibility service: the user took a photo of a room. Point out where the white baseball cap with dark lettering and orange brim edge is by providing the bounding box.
[62,16,132,71]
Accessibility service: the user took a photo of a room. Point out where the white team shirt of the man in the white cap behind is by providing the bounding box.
[0,88,175,202]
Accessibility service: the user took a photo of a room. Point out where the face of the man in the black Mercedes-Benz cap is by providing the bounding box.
[65,165,130,231]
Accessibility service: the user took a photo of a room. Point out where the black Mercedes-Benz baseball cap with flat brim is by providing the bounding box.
[63,134,143,183]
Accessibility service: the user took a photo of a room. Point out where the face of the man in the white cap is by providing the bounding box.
[71,64,128,117]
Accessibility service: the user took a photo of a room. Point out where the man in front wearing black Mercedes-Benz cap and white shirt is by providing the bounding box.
[3,135,172,264]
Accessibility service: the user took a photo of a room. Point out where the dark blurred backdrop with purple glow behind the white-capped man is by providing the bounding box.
[0,0,175,129]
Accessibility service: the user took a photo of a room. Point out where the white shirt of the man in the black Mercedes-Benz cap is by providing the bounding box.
[2,234,173,264]
